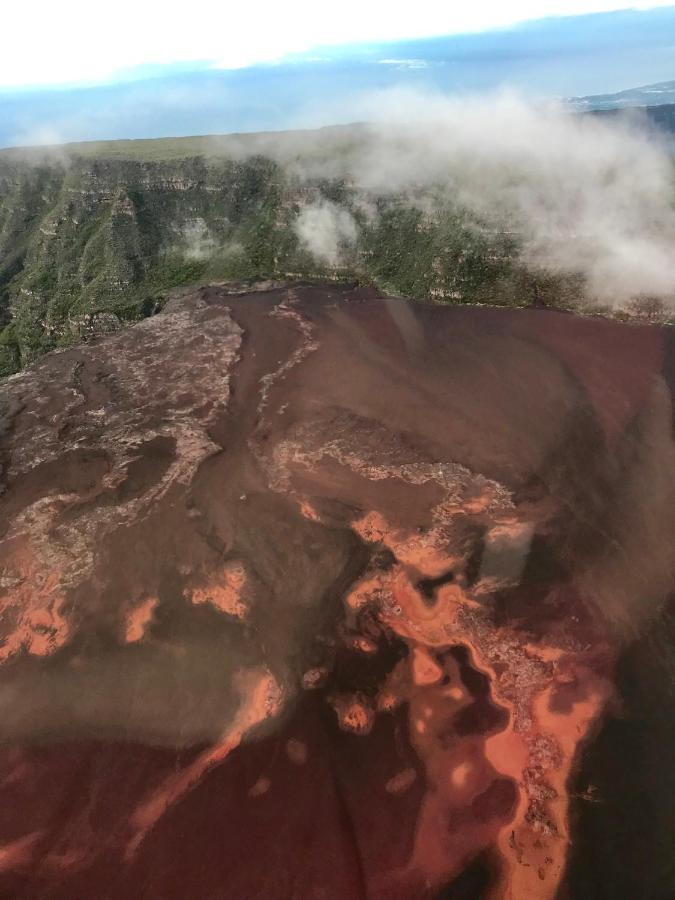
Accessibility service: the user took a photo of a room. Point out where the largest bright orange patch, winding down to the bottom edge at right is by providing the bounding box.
[346,506,611,900]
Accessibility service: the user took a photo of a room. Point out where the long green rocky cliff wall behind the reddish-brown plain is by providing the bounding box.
[0,118,672,376]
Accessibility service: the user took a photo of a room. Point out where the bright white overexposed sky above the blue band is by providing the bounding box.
[5,0,673,90]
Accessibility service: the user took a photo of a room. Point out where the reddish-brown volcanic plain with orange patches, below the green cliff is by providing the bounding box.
[0,286,675,900]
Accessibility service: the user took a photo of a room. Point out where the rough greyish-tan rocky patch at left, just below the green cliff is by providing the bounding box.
[0,296,242,640]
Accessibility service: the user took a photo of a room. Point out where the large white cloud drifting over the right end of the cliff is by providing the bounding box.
[294,89,675,304]
